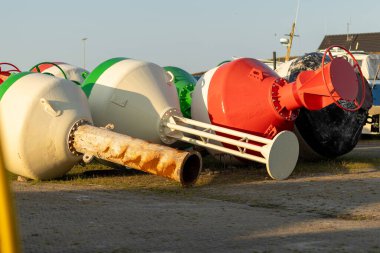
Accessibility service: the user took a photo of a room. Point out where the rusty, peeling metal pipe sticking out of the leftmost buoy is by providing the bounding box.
[69,124,202,186]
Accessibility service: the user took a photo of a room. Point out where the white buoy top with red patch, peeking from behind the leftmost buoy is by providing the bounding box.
[32,62,89,85]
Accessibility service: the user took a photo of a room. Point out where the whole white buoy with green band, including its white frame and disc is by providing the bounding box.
[82,58,298,179]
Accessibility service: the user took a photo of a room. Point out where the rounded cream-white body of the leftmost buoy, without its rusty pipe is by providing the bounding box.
[0,72,92,179]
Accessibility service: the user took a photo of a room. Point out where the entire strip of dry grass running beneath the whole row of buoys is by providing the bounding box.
[10,148,380,194]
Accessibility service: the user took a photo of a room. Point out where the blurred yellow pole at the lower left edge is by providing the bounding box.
[0,143,20,253]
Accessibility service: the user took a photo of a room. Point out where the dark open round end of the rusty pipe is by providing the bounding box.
[180,151,202,187]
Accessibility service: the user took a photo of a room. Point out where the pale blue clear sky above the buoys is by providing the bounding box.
[0,0,380,72]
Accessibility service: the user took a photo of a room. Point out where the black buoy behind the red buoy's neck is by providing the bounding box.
[285,53,372,159]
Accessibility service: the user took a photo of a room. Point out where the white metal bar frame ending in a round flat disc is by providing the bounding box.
[163,115,299,180]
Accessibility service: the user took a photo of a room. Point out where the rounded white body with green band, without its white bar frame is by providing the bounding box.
[82,58,180,143]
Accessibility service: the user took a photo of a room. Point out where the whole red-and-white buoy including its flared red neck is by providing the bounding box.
[192,45,365,157]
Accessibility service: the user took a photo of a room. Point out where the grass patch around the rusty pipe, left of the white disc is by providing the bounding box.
[48,162,269,194]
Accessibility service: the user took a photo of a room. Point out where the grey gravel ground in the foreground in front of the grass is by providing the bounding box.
[12,142,380,253]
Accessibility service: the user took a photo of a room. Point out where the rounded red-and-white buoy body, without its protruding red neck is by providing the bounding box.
[192,58,293,139]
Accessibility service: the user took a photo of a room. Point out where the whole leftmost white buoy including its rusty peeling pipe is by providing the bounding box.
[0,72,202,186]
